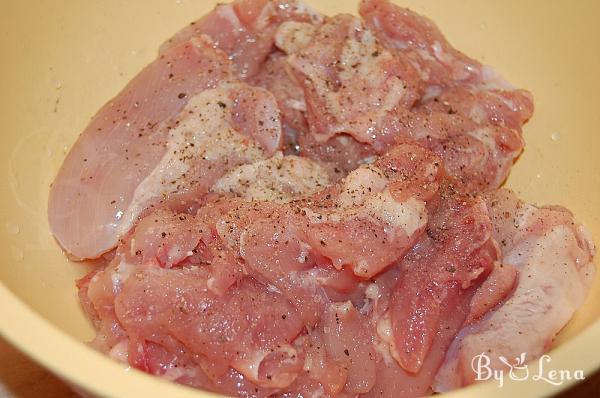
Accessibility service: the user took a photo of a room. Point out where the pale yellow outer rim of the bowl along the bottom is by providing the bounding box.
[0,282,600,398]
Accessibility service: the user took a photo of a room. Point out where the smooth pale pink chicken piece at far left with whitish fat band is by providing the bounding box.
[49,54,281,258]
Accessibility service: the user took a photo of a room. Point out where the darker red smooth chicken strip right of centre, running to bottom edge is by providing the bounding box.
[356,186,498,397]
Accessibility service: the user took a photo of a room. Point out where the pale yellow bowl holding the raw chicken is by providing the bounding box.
[0,0,600,398]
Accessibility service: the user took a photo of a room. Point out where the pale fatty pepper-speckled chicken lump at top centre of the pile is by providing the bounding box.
[277,15,418,153]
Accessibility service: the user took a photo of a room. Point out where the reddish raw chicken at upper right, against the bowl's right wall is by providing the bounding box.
[360,0,533,191]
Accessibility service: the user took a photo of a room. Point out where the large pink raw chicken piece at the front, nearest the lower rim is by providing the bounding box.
[81,145,540,396]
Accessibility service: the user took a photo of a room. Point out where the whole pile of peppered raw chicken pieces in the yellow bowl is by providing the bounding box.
[49,0,594,397]
